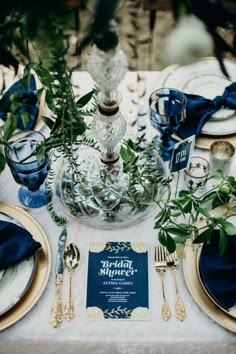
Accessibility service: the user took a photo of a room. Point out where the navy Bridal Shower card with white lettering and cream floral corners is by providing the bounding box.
[86,241,149,320]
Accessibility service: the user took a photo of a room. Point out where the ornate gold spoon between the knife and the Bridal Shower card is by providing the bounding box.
[63,243,80,321]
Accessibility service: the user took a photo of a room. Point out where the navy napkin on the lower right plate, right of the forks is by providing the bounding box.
[199,230,236,309]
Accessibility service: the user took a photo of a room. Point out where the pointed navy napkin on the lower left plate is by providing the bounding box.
[0,221,41,270]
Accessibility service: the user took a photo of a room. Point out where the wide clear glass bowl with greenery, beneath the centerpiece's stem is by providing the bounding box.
[56,144,165,229]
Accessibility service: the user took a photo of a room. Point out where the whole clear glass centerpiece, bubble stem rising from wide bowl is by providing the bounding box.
[56,42,165,229]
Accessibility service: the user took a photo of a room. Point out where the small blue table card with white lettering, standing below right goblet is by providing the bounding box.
[170,135,195,173]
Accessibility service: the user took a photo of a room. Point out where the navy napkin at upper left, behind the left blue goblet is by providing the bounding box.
[0,75,39,130]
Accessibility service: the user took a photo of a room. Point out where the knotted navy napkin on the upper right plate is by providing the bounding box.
[176,82,236,139]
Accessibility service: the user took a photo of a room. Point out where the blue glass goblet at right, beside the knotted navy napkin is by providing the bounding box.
[149,88,187,161]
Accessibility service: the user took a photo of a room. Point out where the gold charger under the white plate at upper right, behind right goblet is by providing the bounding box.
[152,61,236,150]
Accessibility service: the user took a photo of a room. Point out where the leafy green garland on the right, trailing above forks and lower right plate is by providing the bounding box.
[121,142,236,255]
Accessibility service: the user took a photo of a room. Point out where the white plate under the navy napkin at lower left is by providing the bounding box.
[0,213,36,315]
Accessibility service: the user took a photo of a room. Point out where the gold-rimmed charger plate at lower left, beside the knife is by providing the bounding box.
[0,202,51,331]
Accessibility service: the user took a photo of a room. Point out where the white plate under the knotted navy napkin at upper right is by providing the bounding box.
[163,58,236,136]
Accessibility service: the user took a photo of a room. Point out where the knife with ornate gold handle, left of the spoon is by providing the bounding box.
[50,228,67,327]
